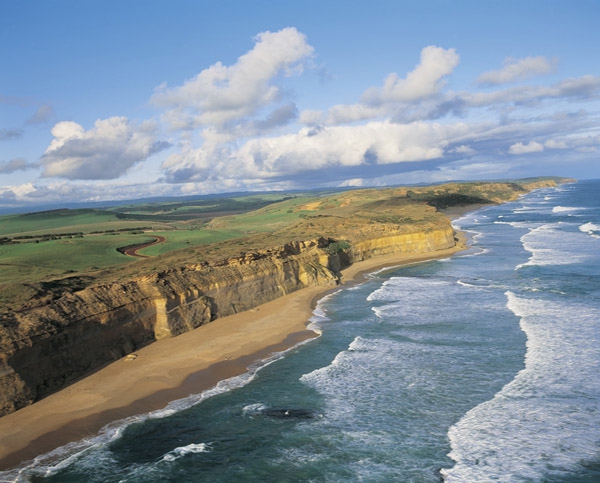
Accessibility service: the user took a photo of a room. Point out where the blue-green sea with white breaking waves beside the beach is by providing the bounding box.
[0,181,600,483]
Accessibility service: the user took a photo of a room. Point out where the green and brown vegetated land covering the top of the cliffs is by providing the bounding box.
[0,179,572,312]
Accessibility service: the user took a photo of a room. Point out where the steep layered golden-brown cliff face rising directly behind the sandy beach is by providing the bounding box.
[0,222,455,415]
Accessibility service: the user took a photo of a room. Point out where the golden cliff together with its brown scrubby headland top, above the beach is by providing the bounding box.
[0,178,568,416]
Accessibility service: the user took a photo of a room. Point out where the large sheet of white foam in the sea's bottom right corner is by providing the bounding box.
[442,292,600,482]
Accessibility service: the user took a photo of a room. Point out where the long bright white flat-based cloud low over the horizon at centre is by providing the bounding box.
[163,121,469,181]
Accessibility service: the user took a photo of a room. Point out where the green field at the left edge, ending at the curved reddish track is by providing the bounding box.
[0,234,154,283]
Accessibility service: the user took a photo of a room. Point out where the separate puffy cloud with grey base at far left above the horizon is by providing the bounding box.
[41,117,167,179]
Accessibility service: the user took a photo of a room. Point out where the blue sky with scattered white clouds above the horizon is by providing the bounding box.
[0,0,600,209]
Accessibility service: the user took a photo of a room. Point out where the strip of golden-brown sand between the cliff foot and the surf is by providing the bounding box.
[0,225,472,470]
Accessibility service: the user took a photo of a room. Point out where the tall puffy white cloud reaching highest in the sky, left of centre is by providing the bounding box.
[152,28,313,129]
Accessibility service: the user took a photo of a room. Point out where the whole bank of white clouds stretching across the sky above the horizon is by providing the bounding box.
[7,36,600,212]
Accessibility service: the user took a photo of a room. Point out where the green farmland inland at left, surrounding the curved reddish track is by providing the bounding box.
[0,193,310,284]
